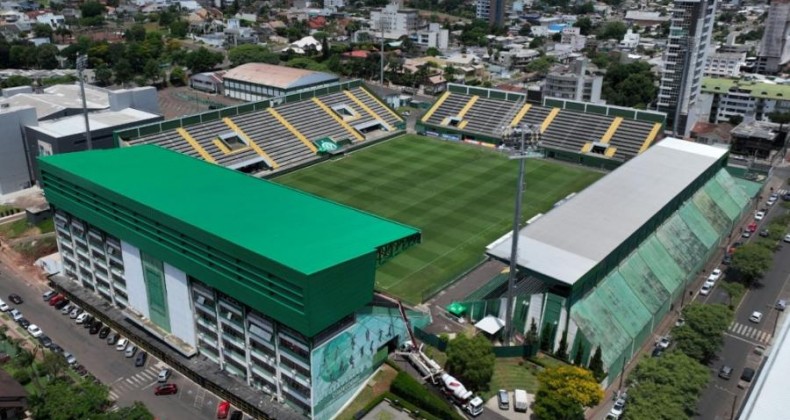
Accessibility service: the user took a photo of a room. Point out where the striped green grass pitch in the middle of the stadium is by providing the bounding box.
[275,135,602,303]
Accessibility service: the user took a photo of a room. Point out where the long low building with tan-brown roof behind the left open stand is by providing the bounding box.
[222,63,340,102]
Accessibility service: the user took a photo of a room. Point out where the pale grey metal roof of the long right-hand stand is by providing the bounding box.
[488,138,727,285]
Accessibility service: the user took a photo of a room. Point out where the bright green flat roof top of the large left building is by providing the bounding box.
[41,146,420,274]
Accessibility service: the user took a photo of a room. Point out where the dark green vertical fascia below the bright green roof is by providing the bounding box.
[40,161,377,337]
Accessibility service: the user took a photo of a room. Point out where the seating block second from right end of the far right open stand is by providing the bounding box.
[540,110,613,152]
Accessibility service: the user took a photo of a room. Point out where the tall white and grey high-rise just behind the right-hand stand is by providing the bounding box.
[658,0,716,136]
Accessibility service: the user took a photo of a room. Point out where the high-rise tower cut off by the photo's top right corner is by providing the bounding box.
[756,0,790,74]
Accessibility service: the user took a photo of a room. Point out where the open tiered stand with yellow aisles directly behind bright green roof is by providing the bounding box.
[114,81,405,175]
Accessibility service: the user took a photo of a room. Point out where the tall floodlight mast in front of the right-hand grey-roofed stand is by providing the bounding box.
[502,124,543,344]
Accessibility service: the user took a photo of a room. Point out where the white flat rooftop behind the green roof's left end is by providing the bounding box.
[30,108,162,137]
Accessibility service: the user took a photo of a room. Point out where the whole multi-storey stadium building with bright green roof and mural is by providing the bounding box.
[39,145,427,419]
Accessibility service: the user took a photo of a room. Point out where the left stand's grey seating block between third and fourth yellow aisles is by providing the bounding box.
[276,100,354,141]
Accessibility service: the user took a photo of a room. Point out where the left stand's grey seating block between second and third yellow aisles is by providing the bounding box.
[233,111,315,166]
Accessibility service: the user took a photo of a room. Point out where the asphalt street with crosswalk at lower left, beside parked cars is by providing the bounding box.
[0,265,238,420]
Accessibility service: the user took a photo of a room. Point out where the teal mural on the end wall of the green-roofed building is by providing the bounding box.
[310,307,430,420]
